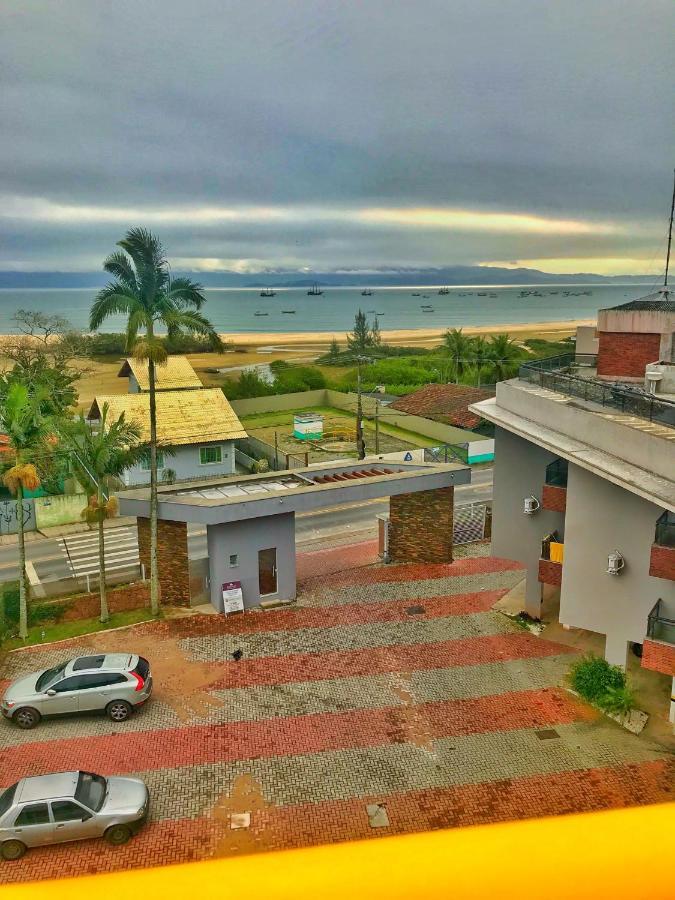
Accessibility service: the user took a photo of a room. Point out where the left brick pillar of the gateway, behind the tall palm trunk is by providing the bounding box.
[137,516,190,606]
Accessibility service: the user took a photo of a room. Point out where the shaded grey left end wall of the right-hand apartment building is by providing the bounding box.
[492,428,565,618]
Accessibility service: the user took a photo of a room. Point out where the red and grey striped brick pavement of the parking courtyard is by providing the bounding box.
[0,545,675,882]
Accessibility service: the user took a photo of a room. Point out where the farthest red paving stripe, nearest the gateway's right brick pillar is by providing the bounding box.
[303,556,524,590]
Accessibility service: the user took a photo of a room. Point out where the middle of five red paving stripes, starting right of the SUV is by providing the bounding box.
[210,633,576,690]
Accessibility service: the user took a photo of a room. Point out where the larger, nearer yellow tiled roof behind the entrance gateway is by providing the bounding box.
[89,388,246,446]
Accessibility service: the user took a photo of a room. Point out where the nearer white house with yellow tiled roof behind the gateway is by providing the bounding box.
[89,388,247,486]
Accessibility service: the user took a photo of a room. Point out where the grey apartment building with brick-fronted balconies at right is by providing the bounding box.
[472,292,675,718]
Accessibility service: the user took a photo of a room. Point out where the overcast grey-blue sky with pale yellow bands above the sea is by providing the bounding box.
[0,0,675,274]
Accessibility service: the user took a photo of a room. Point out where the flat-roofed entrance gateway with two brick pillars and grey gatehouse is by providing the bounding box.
[119,459,471,612]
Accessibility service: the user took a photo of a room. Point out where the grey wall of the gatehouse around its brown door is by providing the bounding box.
[206,513,295,612]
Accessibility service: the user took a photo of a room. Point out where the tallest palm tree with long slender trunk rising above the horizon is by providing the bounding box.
[89,228,217,615]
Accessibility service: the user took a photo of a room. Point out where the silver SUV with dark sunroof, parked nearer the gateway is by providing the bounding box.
[1,653,152,728]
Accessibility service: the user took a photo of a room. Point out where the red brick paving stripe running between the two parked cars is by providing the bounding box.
[0,688,596,785]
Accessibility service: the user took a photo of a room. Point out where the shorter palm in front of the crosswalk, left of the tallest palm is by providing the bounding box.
[64,403,147,622]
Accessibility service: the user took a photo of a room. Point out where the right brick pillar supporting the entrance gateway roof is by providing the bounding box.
[389,487,455,563]
